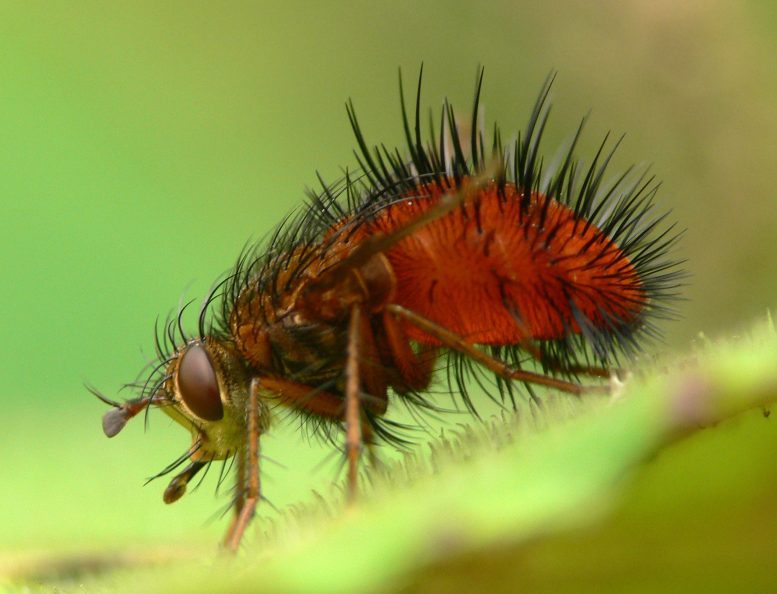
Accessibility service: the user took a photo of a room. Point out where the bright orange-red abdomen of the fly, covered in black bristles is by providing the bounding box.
[368,184,646,345]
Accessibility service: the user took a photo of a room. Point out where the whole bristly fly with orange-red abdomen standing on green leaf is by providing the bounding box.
[98,73,682,549]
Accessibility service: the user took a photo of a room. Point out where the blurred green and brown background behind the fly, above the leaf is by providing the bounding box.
[0,0,777,551]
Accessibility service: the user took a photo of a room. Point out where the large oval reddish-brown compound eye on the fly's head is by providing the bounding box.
[178,344,224,421]
